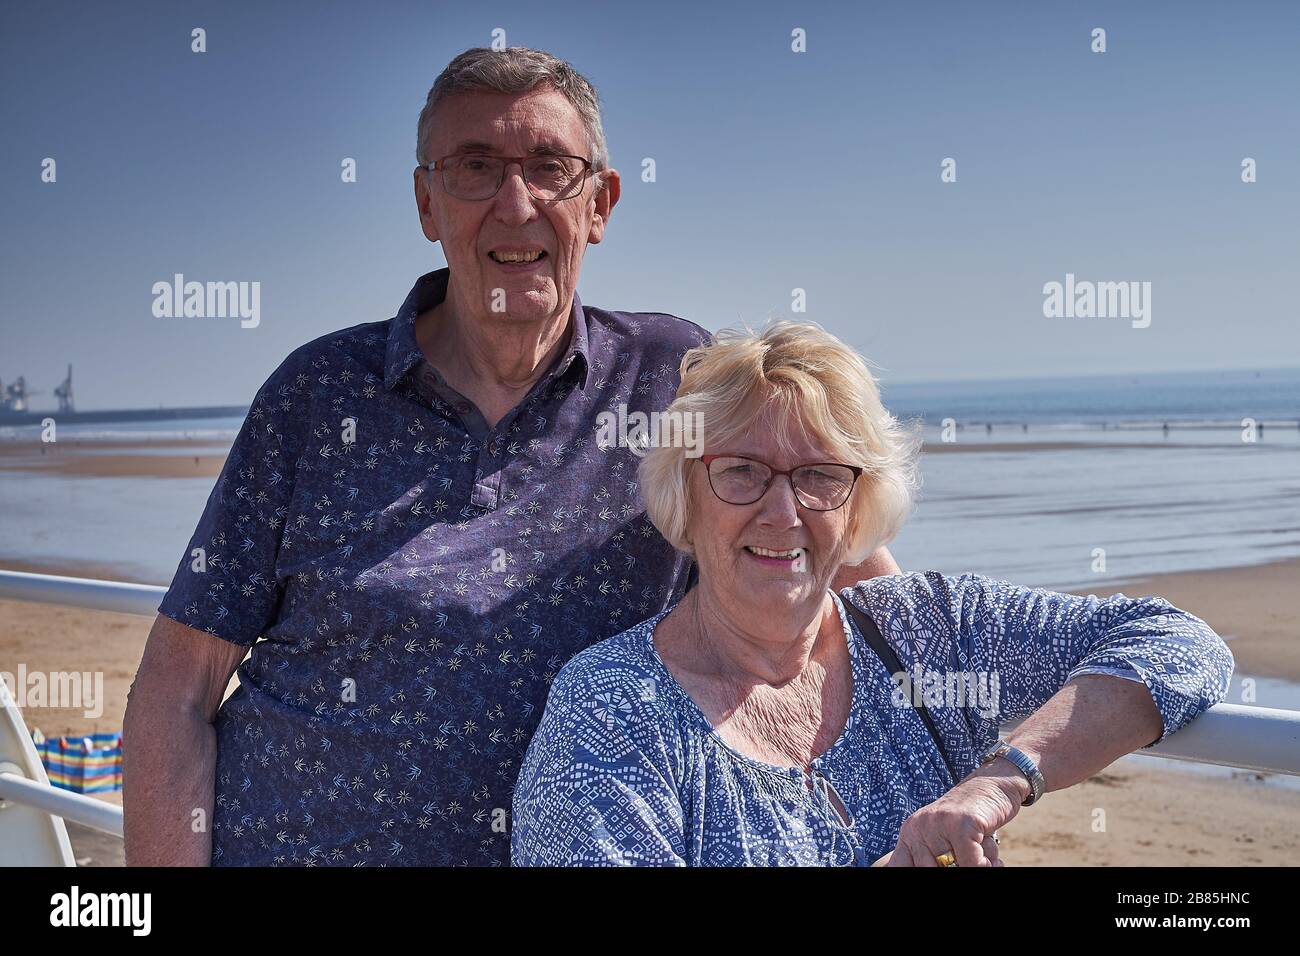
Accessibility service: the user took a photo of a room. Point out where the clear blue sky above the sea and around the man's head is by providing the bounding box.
[0,0,1300,408]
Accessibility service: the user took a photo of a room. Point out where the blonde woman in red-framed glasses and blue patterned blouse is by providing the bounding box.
[512,324,1232,866]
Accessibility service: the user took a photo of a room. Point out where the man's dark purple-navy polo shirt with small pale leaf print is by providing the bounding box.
[160,269,707,865]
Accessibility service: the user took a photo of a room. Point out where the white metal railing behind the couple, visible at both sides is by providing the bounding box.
[0,571,1300,858]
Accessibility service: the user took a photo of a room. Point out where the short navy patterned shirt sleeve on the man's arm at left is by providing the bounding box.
[159,352,308,646]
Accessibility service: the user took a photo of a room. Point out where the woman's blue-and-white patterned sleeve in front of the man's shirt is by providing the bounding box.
[511,645,686,866]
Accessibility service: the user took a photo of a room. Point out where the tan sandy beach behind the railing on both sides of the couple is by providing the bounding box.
[0,441,1300,866]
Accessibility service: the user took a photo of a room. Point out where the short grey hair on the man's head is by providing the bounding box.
[415,47,610,187]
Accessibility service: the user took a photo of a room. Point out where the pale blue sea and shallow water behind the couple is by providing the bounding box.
[0,368,1300,589]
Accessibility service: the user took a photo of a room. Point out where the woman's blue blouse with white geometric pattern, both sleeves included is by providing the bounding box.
[512,571,1232,866]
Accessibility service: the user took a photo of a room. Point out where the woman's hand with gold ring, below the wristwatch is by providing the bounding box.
[871,761,1028,866]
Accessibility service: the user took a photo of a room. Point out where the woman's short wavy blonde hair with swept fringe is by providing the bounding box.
[640,321,922,564]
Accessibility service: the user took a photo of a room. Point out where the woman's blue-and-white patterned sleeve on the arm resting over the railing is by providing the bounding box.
[943,575,1234,749]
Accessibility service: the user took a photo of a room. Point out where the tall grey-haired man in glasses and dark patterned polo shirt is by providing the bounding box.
[125,48,897,865]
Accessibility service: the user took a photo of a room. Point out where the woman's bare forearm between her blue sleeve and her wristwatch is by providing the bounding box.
[971,674,1165,800]
